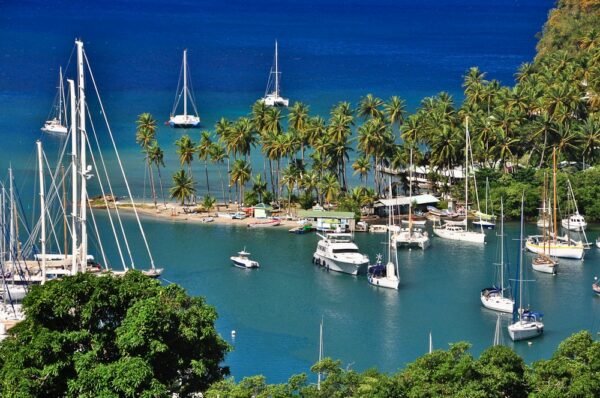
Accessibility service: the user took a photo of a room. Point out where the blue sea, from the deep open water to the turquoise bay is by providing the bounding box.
[0,0,600,382]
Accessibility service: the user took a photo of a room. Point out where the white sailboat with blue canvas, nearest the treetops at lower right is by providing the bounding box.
[508,193,544,341]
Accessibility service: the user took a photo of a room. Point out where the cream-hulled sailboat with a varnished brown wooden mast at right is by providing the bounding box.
[525,148,584,260]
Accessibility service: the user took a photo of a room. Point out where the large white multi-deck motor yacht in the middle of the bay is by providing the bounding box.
[313,233,369,275]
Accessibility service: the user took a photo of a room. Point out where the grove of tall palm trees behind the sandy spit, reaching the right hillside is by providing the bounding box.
[143,23,600,215]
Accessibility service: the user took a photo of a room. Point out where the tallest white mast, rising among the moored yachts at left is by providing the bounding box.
[75,40,88,271]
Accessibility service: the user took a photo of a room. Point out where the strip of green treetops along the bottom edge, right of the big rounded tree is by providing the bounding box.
[205,332,600,398]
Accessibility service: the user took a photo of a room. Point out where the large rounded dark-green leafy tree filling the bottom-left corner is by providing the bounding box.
[0,272,229,397]
